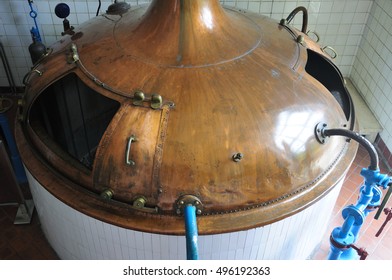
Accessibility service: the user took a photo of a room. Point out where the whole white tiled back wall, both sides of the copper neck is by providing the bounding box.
[0,0,374,86]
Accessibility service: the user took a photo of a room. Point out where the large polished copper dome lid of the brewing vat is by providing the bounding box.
[16,0,356,234]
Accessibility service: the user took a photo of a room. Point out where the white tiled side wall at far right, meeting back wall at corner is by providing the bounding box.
[351,0,392,151]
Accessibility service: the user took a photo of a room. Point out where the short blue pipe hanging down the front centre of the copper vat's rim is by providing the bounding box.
[184,204,199,260]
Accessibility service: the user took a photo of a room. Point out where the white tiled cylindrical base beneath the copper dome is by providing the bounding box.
[27,167,342,260]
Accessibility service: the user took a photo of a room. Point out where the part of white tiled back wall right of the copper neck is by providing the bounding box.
[222,0,373,76]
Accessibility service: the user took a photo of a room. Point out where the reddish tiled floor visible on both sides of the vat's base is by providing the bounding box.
[0,144,392,260]
